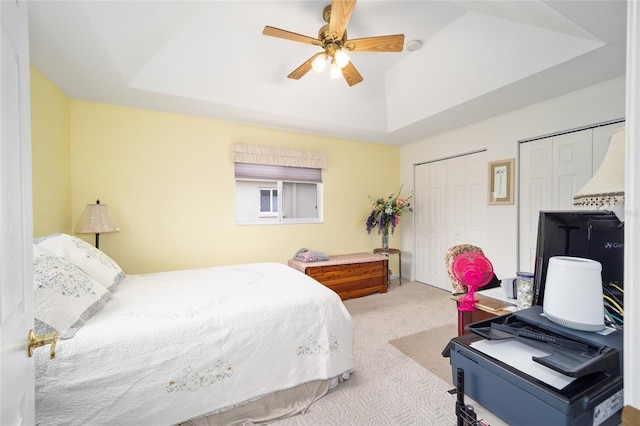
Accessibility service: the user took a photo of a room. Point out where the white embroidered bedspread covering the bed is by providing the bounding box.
[35,263,353,426]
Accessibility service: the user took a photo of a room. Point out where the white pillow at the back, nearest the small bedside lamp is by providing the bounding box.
[36,234,125,292]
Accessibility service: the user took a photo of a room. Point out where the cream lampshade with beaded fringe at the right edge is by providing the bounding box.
[573,127,625,220]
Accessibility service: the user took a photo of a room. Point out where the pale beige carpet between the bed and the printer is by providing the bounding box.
[273,280,457,426]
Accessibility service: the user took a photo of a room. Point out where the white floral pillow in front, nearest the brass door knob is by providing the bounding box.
[33,244,111,339]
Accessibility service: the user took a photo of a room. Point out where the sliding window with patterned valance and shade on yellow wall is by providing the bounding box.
[231,144,327,225]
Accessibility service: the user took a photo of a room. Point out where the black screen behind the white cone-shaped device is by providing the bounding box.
[533,210,624,306]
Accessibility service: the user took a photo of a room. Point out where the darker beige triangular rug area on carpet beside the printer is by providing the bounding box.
[389,324,458,385]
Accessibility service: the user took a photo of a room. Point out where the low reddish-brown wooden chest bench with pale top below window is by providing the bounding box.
[288,253,389,300]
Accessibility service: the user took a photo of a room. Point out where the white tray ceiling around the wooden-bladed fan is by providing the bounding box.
[29,0,626,145]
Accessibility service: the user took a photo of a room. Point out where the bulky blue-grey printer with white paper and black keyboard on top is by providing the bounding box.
[443,306,623,426]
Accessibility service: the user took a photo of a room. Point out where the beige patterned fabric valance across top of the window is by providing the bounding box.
[231,143,327,169]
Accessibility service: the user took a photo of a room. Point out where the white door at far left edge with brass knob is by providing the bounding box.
[0,1,35,426]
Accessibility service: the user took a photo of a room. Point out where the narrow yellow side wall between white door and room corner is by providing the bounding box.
[31,67,72,236]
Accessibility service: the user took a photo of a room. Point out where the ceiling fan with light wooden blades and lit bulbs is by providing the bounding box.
[262,0,404,86]
